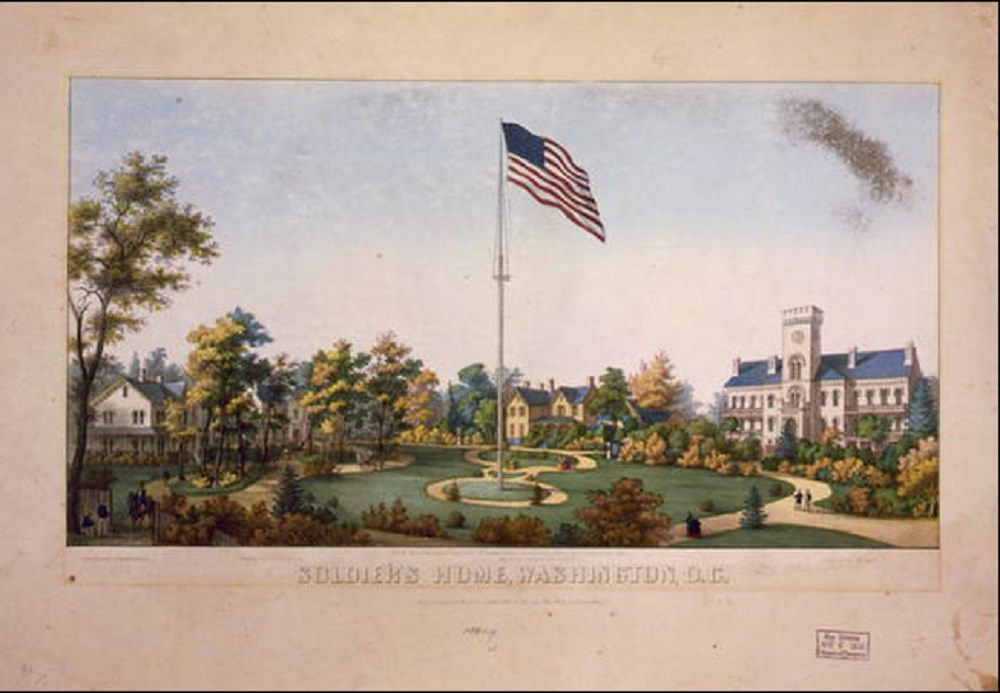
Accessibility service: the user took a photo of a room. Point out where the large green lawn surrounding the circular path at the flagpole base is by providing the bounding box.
[303,447,793,530]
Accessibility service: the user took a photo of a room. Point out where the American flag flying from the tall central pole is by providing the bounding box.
[503,123,604,243]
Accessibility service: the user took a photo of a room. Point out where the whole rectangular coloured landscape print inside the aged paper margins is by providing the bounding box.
[67,79,939,548]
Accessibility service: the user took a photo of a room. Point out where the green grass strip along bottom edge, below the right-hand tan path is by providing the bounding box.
[675,524,889,549]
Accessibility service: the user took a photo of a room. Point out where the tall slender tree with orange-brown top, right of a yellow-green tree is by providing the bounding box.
[366,332,423,461]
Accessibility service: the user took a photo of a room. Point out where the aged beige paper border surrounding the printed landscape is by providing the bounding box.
[0,3,997,689]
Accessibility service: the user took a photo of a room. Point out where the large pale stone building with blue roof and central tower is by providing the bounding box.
[722,306,921,448]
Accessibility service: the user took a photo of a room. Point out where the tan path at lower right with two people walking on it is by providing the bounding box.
[670,472,939,549]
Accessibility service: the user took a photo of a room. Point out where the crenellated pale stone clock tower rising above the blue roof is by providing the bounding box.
[781,306,823,438]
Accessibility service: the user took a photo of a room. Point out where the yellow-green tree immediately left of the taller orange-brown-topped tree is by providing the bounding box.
[301,339,371,463]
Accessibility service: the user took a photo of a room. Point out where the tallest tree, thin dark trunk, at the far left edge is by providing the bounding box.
[66,152,218,533]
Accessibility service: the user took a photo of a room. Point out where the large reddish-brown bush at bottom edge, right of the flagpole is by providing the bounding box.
[576,478,670,546]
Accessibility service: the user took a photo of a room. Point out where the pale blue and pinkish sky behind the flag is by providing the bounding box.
[71,79,937,400]
